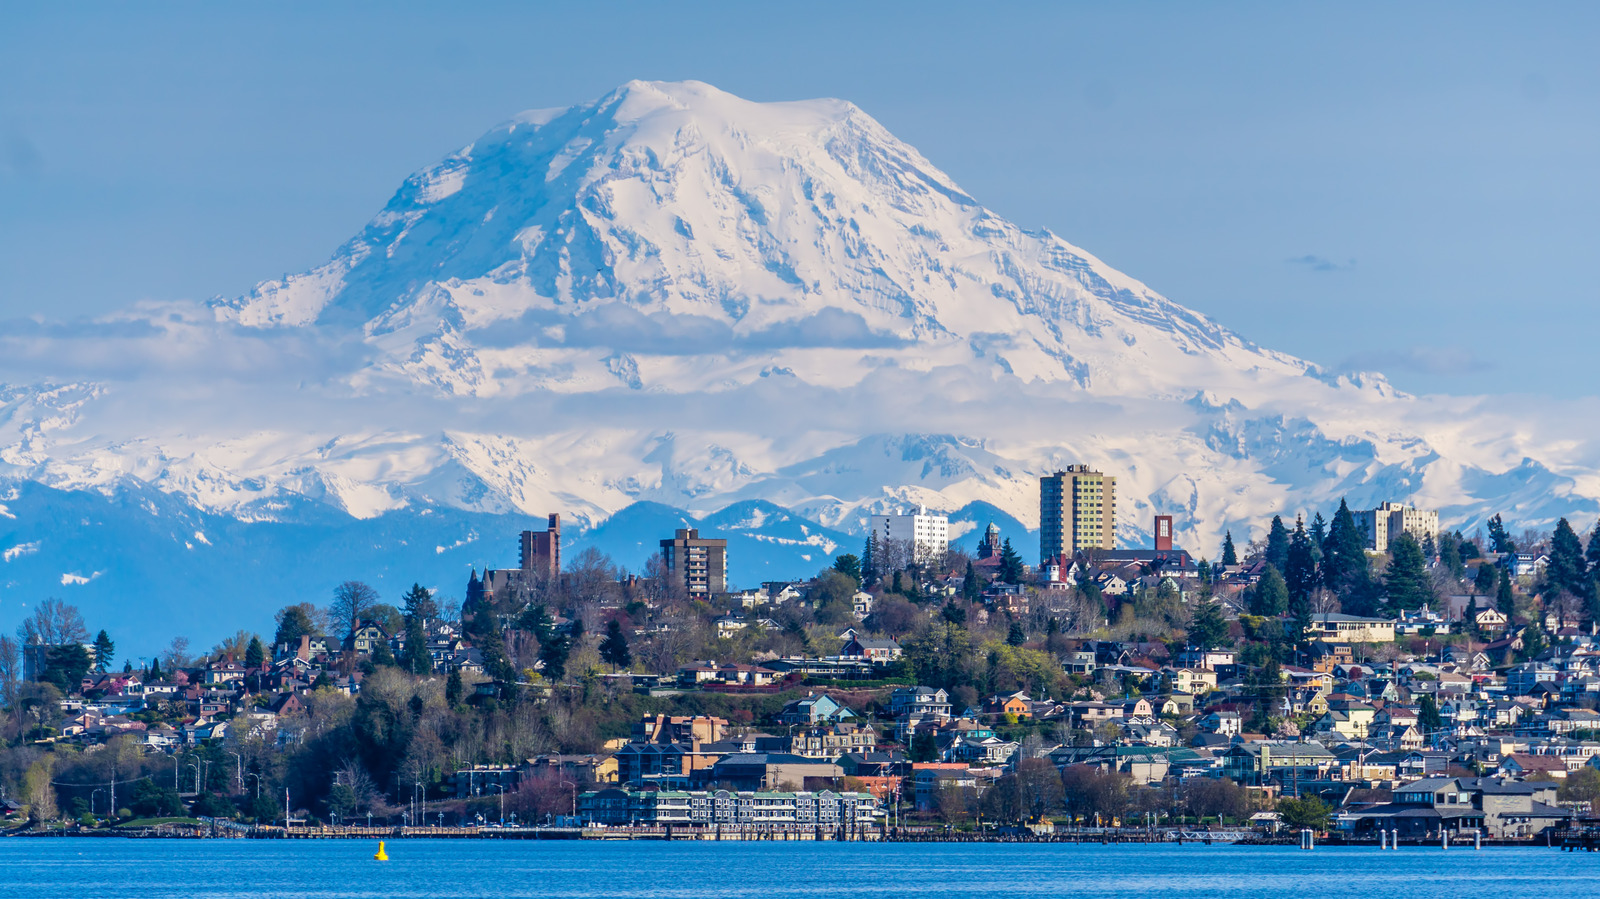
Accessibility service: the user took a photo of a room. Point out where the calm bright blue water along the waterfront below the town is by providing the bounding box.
[0,838,1600,899]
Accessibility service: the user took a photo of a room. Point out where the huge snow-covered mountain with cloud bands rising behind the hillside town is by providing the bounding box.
[0,82,1600,643]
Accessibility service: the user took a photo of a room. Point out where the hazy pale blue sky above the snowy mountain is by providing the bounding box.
[0,2,1600,397]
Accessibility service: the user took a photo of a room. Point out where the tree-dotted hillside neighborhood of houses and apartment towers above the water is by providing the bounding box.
[0,476,1600,841]
